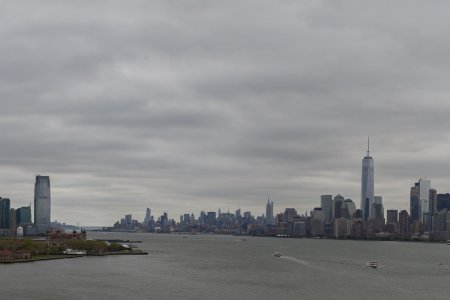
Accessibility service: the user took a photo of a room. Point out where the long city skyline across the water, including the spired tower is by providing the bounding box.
[109,143,450,240]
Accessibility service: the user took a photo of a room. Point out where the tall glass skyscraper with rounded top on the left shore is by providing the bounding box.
[34,175,51,233]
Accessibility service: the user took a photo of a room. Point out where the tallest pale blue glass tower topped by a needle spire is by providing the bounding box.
[361,139,374,220]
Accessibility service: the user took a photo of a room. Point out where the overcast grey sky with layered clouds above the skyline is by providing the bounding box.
[0,0,450,226]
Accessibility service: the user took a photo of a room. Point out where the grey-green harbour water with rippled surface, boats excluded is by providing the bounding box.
[0,233,450,299]
